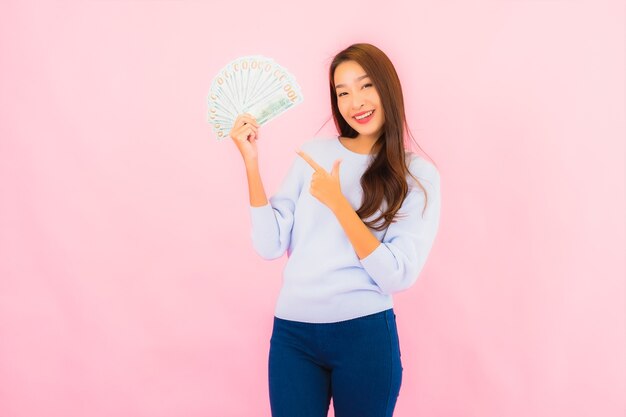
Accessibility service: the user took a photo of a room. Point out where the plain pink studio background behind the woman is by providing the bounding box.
[0,0,626,417]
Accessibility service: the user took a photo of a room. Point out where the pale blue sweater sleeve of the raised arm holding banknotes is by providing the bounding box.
[250,157,302,260]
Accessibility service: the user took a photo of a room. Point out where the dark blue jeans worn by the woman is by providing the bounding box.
[268,309,402,417]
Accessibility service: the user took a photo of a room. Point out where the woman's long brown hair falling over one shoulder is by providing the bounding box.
[328,43,428,231]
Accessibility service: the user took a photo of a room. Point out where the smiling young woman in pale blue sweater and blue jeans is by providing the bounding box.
[230,43,440,417]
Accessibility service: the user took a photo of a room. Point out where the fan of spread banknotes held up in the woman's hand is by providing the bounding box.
[209,55,303,140]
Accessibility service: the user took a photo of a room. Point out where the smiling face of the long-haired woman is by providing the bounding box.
[334,61,385,139]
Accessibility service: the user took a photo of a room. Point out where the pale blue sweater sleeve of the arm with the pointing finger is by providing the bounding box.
[361,158,441,294]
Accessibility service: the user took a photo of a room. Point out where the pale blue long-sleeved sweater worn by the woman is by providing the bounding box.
[250,136,441,323]
